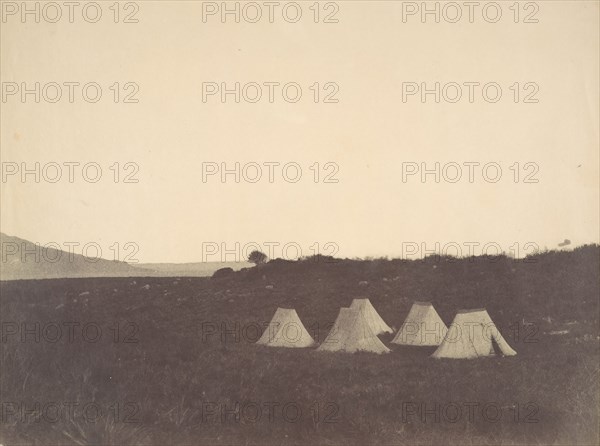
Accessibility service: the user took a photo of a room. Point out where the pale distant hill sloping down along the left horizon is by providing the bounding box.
[0,233,253,280]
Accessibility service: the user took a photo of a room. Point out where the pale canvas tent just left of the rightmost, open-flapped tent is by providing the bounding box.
[392,302,448,345]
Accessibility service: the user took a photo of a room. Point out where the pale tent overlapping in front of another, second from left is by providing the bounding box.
[317,308,390,353]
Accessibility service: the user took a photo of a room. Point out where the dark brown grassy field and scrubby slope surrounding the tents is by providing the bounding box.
[0,246,600,446]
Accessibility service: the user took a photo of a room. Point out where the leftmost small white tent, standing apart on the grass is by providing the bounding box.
[256,308,316,348]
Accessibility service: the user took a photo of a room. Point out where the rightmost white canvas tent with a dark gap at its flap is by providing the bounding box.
[431,308,517,358]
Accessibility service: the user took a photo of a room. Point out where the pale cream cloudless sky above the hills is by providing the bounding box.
[0,1,600,262]
